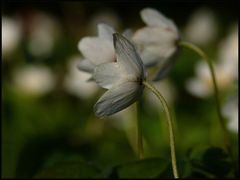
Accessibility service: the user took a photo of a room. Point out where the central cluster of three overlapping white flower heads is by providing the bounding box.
[78,8,179,117]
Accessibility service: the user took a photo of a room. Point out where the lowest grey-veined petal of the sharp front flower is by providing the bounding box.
[94,82,144,117]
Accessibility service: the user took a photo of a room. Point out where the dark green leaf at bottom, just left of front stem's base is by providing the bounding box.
[117,158,169,178]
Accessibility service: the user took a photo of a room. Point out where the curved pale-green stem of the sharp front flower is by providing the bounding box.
[143,81,179,178]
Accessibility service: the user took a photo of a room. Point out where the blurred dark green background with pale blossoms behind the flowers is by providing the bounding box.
[2,1,238,178]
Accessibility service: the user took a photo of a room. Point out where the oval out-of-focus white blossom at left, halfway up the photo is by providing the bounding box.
[13,65,56,95]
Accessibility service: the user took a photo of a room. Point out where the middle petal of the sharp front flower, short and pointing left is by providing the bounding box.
[93,63,125,89]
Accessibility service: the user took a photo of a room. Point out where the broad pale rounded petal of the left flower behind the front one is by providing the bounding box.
[78,37,115,65]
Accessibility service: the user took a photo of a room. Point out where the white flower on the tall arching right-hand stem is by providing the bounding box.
[132,8,180,66]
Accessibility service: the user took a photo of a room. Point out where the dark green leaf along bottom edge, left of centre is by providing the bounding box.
[34,162,100,178]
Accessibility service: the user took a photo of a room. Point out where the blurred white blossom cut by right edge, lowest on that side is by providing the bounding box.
[222,96,238,133]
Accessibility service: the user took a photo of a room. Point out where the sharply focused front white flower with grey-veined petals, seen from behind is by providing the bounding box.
[93,33,145,117]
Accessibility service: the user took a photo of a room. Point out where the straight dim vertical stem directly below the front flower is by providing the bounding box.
[136,101,143,159]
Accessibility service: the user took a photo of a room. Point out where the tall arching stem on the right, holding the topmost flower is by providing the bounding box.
[179,41,232,156]
